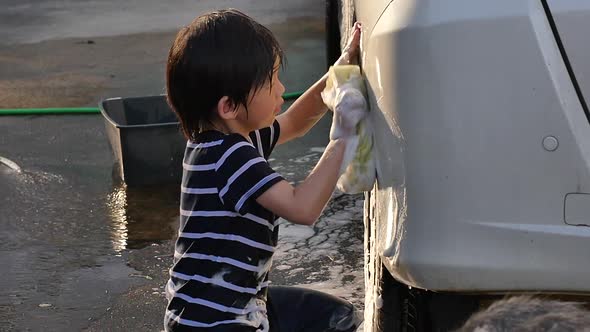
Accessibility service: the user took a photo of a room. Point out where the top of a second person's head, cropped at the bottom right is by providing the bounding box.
[456,296,590,332]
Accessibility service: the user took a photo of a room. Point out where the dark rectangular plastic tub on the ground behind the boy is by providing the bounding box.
[99,96,186,186]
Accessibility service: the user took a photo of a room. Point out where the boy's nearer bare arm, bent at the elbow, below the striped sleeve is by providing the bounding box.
[256,138,347,225]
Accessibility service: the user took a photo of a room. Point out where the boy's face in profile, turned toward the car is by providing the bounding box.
[242,62,285,130]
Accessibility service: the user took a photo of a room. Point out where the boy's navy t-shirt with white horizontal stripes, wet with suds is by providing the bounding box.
[165,121,283,331]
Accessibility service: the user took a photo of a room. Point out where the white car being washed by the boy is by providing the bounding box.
[327,0,590,331]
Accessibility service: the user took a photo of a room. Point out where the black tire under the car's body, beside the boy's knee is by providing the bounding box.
[364,191,479,332]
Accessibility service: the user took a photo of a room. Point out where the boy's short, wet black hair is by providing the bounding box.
[166,9,284,139]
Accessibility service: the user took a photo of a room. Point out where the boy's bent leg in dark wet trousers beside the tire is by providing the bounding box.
[267,286,362,332]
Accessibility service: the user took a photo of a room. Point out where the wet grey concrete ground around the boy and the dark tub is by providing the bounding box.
[0,0,363,331]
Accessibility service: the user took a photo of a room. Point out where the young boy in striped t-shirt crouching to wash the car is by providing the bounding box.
[165,9,360,332]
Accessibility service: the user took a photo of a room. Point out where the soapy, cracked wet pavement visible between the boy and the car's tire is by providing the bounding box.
[270,147,365,331]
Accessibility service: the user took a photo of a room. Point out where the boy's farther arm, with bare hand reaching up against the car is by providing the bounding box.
[277,23,361,144]
